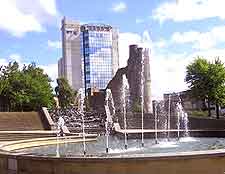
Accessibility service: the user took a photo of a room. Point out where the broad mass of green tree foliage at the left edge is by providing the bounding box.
[0,62,53,111]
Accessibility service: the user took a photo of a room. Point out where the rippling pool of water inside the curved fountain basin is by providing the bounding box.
[13,136,225,157]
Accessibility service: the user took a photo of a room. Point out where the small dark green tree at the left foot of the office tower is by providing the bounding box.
[55,78,76,108]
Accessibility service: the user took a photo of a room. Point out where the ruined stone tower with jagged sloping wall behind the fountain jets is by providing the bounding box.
[107,45,152,113]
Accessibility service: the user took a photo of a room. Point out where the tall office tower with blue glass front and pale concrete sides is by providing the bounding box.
[59,19,119,92]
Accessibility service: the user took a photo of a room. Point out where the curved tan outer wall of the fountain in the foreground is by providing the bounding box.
[0,150,225,174]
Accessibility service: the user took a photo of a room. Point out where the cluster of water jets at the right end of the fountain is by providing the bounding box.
[149,94,189,141]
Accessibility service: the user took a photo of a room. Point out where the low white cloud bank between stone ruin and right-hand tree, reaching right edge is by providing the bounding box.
[150,44,225,99]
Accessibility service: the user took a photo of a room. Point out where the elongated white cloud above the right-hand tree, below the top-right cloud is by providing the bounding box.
[171,25,225,50]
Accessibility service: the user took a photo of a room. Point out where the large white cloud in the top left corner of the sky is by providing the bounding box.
[0,0,58,37]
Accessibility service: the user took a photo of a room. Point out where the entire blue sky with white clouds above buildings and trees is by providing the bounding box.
[0,0,225,99]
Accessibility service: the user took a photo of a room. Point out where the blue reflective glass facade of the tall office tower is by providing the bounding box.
[80,26,113,90]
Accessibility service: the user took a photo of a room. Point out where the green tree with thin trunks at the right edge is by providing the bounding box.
[185,57,225,118]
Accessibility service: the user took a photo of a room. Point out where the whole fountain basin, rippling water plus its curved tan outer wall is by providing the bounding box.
[0,133,225,174]
